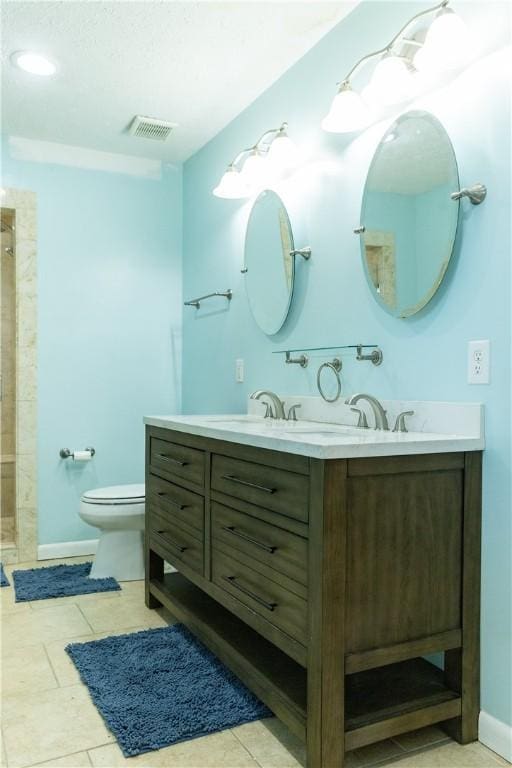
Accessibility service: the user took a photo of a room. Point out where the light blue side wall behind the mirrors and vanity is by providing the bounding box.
[183,2,512,723]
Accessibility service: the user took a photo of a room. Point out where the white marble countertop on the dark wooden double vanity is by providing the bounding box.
[144,398,484,459]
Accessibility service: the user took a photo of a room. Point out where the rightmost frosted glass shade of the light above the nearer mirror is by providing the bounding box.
[414,8,470,72]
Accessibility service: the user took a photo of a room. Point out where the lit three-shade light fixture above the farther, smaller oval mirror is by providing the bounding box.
[213,123,298,199]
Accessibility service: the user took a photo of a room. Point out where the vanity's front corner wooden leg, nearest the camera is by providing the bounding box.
[306,459,347,768]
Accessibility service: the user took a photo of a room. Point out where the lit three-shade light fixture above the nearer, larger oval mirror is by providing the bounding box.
[322,0,469,133]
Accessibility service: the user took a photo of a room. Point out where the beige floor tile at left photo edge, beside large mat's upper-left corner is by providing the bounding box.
[1,644,58,696]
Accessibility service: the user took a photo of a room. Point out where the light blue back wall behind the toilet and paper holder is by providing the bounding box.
[2,146,182,544]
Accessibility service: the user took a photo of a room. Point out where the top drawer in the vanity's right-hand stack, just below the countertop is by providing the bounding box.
[211,454,309,522]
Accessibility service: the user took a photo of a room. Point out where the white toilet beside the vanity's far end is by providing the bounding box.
[80,483,146,581]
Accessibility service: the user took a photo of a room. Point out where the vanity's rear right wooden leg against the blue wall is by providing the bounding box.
[443,451,482,744]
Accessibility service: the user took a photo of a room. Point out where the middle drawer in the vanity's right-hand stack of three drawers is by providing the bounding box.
[212,502,308,585]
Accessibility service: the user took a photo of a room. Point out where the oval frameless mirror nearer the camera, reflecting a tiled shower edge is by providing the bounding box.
[361,111,459,317]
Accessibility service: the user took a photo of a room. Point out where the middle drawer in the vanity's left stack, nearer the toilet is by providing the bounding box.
[147,475,204,536]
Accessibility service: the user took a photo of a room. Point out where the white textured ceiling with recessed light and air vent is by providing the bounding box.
[1,0,357,162]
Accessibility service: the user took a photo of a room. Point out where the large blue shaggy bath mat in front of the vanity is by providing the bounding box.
[66,624,271,757]
